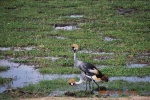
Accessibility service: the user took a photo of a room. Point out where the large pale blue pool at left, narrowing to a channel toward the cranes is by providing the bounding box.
[0,60,77,92]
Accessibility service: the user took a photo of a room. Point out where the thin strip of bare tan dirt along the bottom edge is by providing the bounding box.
[20,96,150,100]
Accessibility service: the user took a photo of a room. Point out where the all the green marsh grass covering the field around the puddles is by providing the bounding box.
[0,0,150,99]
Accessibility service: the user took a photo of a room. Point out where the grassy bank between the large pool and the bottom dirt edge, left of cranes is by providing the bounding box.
[0,79,69,99]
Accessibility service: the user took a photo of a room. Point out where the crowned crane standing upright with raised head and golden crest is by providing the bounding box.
[72,44,108,90]
